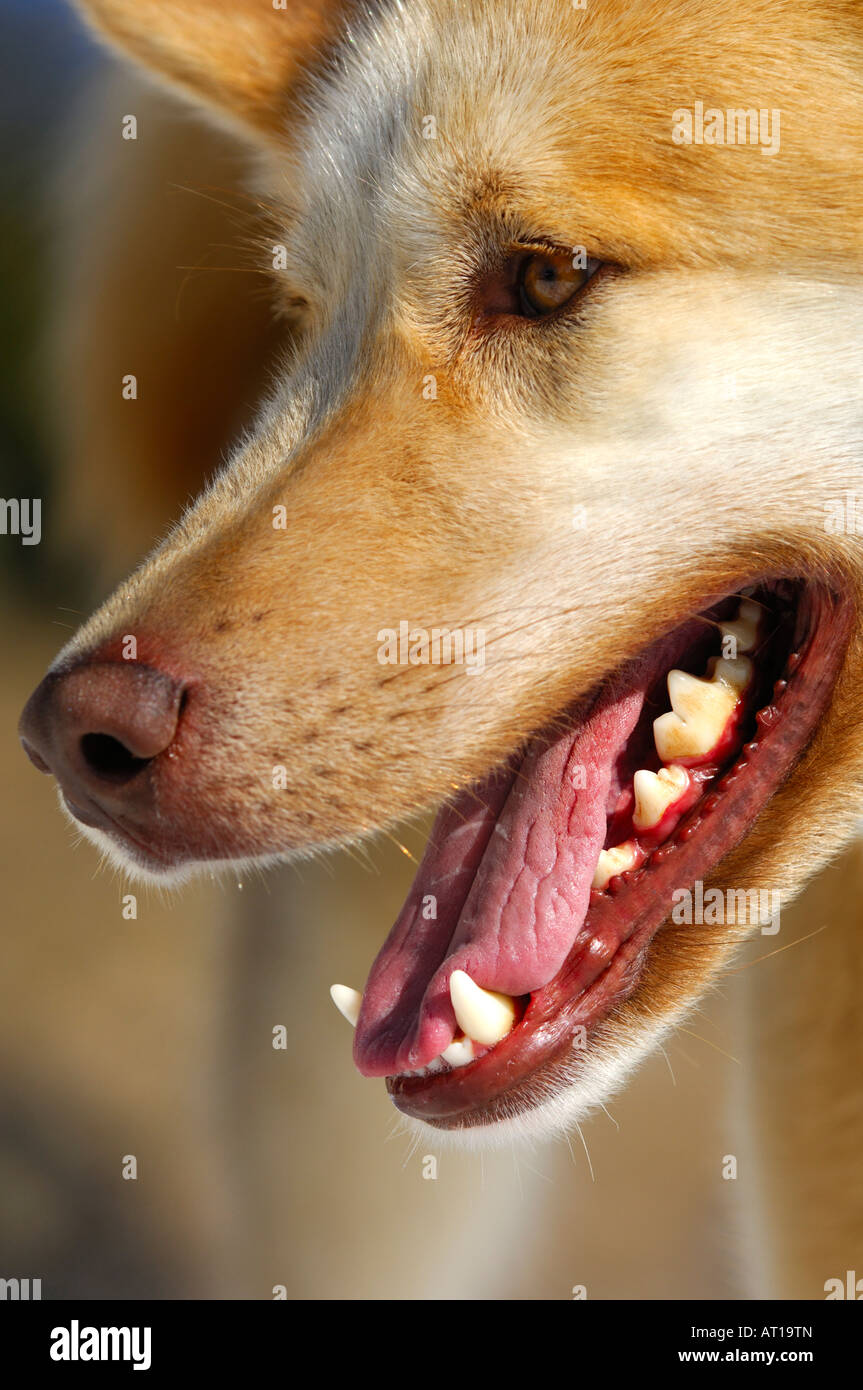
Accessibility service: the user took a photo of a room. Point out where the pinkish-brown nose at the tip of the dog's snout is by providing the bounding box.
[18,662,183,824]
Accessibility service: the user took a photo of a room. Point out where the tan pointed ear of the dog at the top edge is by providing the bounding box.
[78,0,352,135]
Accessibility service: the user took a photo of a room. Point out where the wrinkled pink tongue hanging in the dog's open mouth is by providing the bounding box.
[354,678,645,1076]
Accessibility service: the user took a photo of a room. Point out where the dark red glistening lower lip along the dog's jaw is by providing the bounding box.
[386,575,853,1129]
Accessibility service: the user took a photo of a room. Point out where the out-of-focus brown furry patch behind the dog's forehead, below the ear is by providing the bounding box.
[51,72,285,582]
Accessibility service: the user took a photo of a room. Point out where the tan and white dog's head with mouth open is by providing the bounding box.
[22,0,863,1138]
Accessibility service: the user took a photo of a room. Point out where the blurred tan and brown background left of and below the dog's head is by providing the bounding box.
[0,0,750,1300]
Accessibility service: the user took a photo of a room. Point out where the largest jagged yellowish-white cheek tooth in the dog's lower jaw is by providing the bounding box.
[653,656,752,763]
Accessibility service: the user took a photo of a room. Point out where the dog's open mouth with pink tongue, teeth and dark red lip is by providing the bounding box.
[334,578,852,1129]
